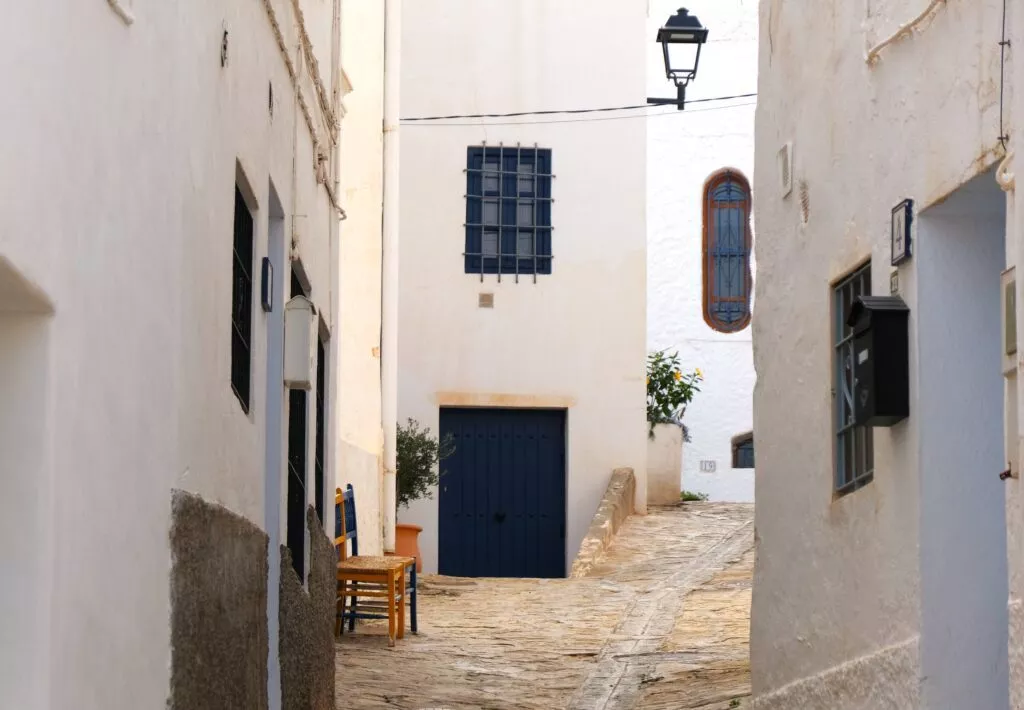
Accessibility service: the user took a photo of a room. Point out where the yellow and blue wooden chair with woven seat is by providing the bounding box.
[334,484,417,645]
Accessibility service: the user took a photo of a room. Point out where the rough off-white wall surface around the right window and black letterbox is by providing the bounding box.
[751,0,1020,708]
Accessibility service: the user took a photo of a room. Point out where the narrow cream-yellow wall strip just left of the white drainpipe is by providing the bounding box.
[335,0,384,554]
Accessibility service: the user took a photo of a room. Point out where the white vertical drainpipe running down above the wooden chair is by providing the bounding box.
[381,0,401,552]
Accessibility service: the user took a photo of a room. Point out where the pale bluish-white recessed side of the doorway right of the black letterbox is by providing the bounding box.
[915,173,1009,709]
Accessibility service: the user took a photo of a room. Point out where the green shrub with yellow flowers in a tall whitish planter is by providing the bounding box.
[647,350,703,505]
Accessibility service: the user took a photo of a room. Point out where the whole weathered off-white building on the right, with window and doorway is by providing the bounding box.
[751,0,1024,710]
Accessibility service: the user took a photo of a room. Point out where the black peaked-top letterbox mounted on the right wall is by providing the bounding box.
[846,296,910,426]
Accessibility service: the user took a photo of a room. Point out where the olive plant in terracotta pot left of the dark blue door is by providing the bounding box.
[394,419,455,571]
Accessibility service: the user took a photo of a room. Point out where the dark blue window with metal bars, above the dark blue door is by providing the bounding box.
[464,147,553,281]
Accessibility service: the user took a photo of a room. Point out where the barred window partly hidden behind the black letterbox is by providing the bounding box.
[833,262,874,495]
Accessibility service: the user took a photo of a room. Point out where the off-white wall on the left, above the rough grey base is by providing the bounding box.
[0,0,364,710]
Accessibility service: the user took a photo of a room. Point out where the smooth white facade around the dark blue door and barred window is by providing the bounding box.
[398,0,650,571]
